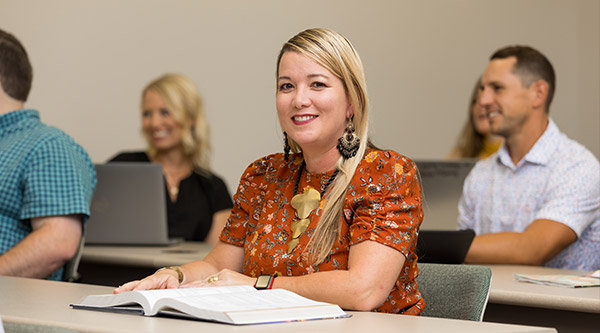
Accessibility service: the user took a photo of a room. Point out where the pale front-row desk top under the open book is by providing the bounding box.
[0,277,556,333]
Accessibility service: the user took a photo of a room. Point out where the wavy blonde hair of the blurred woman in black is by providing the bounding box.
[141,74,211,172]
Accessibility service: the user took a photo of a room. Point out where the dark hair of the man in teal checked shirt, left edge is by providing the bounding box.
[0,29,33,102]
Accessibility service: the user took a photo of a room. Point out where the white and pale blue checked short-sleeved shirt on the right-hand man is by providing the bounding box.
[458,120,600,271]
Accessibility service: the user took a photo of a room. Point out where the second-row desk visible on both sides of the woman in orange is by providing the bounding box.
[80,242,600,332]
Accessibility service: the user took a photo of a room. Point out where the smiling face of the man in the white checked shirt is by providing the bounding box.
[479,57,533,138]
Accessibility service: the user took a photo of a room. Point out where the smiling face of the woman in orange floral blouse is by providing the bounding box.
[277,51,352,154]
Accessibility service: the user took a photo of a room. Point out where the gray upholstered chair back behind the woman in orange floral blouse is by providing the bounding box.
[417,263,492,321]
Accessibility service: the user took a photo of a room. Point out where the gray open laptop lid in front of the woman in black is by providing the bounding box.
[85,162,173,245]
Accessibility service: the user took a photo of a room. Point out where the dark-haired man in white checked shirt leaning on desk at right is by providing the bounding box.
[458,45,600,271]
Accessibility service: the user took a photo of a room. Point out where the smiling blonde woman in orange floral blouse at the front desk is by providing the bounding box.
[115,29,424,315]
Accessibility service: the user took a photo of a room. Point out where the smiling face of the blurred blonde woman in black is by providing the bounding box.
[142,90,183,153]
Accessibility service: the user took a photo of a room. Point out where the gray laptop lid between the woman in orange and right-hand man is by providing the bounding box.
[415,159,477,230]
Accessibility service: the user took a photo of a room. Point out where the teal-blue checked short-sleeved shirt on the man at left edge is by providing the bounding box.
[0,110,96,280]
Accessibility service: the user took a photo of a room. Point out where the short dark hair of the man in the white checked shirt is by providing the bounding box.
[490,45,556,112]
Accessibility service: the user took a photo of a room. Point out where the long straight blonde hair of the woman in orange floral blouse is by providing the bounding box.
[276,28,369,265]
